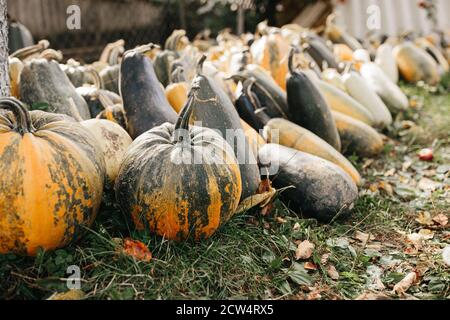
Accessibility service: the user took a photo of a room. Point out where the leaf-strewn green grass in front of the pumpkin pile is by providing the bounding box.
[0,82,450,299]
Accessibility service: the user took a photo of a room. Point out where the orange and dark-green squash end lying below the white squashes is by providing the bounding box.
[333,111,383,157]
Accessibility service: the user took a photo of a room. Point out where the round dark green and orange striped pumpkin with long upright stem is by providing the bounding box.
[115,88,242,241]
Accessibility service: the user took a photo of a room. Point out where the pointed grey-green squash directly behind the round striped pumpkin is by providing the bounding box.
[191,56,261,198]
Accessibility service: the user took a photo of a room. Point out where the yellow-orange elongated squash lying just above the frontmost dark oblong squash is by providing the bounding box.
[264,118,361,185]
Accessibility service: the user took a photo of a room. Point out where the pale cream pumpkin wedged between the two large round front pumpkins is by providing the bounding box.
[80,119,133,186]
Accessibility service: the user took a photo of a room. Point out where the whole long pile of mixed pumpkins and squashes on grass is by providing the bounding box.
[0,19,449,255]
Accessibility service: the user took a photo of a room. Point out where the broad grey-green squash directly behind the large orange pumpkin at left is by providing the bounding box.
[20,59,91,120]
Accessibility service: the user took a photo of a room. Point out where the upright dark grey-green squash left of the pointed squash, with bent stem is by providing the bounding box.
[120,46,177,139]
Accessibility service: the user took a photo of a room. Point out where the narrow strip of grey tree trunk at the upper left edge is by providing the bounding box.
[0,0,9,97]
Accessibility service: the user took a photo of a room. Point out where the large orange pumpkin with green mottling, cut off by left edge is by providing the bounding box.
[0,98,105,255]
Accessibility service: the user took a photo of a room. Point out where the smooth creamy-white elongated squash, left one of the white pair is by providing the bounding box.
[342,71,392,127]
